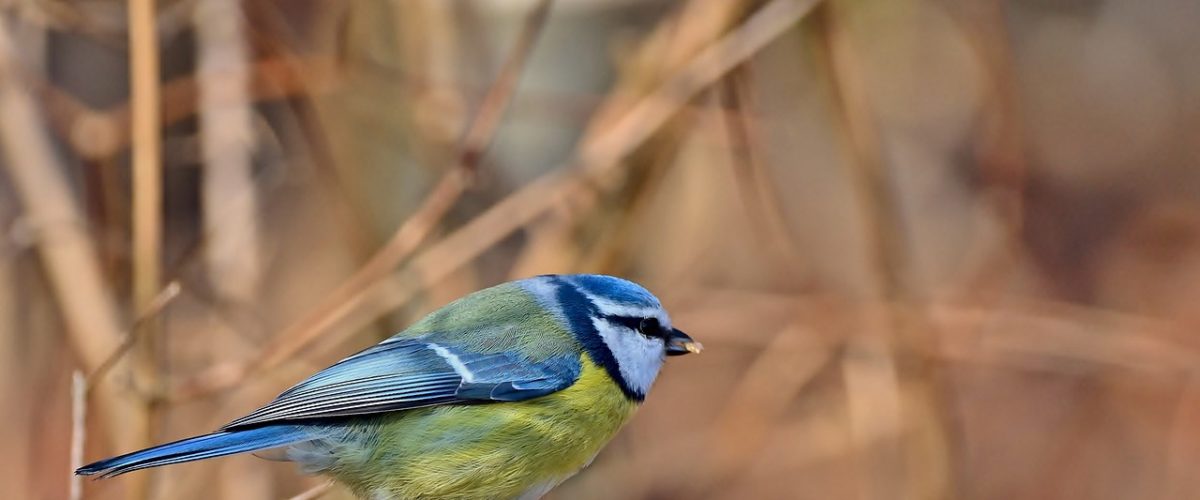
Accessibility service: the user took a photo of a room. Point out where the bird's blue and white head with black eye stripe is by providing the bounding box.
[523,275,702,400]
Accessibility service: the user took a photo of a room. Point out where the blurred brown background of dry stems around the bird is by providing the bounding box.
[0,0,1200,500]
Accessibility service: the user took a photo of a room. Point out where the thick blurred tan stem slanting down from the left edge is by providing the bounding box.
[0,11,148,484]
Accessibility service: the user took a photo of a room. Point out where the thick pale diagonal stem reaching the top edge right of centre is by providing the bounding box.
[283,0,816,369]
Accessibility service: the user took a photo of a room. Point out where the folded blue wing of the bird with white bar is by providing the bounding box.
[222,337,581,430]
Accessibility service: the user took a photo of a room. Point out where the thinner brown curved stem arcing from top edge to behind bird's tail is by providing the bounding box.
[175,0,552,399]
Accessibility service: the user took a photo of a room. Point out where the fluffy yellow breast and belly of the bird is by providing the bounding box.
[329,356,637,499]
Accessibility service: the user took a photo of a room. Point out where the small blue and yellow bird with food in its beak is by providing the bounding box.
[76,275,701,500]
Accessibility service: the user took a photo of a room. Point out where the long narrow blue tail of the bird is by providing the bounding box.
[76,426,317,477]
